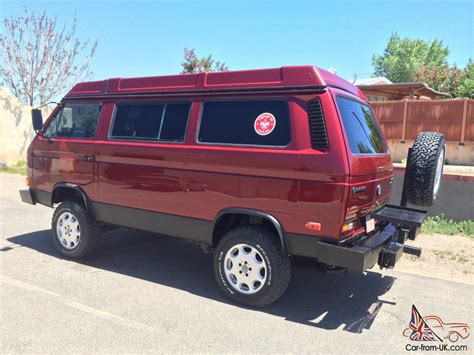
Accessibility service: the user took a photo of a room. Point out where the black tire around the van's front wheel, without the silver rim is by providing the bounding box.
[51,201,100,259]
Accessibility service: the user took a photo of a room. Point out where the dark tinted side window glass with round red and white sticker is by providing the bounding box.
[199,100,290,146]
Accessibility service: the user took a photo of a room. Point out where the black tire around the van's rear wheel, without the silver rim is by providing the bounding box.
[214,226,291,307]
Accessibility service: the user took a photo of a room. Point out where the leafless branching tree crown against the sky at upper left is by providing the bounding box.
[0,8,97,106]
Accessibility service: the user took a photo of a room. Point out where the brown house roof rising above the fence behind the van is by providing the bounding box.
[358,82,448,98]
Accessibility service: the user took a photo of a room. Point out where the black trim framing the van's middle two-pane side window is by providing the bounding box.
[107,100,194,145]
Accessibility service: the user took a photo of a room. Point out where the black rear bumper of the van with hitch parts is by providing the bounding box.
[287,223,421,271]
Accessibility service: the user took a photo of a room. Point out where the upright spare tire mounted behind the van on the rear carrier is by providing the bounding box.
[405,132,445,207]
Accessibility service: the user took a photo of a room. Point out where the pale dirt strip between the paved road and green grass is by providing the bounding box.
[396,234,474,285]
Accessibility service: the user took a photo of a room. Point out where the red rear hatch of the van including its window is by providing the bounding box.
[335,90,393,220]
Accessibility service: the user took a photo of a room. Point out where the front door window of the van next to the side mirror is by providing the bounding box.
[55,104,101,138]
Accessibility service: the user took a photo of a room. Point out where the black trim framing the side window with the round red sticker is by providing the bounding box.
[195,97,293,149]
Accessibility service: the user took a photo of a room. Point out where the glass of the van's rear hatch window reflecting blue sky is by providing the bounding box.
[336,96,387,154]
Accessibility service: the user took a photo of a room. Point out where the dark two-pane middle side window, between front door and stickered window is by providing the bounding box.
[111,103,191,142]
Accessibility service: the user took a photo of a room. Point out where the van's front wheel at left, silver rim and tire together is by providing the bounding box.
[51,201,99,259]
